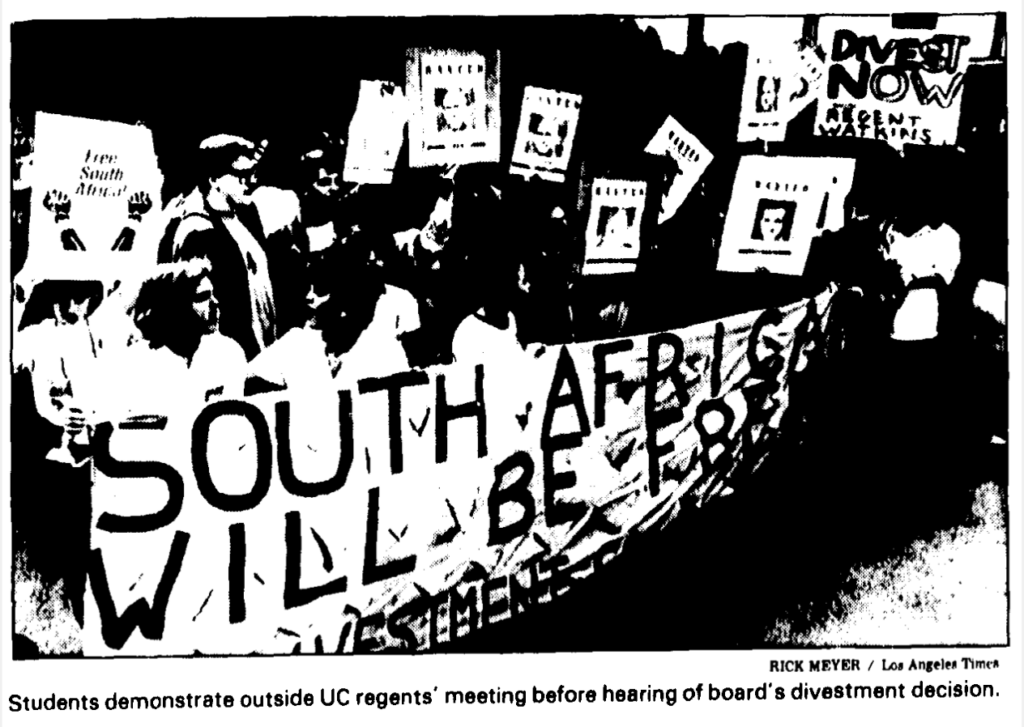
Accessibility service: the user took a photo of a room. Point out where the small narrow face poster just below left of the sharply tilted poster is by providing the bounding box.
[583,179,647,275]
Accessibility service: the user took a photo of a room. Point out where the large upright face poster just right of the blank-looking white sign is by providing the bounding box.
[407,49,501,167]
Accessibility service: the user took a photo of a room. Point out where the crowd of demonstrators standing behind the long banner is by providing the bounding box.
[11,18,1006,650]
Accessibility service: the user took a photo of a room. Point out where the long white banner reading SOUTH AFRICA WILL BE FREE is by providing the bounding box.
[84,292,830,656]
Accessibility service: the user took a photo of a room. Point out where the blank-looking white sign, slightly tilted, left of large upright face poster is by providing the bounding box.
[342,81,407,184]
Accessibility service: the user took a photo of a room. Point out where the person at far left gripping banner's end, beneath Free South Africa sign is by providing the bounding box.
[10,280,103,654]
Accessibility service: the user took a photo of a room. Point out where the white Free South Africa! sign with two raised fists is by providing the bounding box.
[26,113,163,280]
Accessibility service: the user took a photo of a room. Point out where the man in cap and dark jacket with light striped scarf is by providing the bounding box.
[158,135,276,359]
